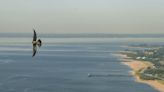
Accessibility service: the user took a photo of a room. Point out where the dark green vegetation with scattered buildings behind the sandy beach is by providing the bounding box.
[121,45,164,84]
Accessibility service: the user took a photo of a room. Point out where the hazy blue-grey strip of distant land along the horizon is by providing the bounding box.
[0,31,164,38]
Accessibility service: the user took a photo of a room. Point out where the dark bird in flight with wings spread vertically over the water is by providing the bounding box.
[32,29,42,57]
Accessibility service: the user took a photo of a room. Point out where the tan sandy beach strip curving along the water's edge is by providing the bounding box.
[114,53,164,92]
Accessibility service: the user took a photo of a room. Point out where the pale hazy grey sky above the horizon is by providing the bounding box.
[0,0,164,34]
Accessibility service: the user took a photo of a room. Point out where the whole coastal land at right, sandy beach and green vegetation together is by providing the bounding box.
[120,44,164,92]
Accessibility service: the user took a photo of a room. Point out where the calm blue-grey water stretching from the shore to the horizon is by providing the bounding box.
[0,34,164,92]
